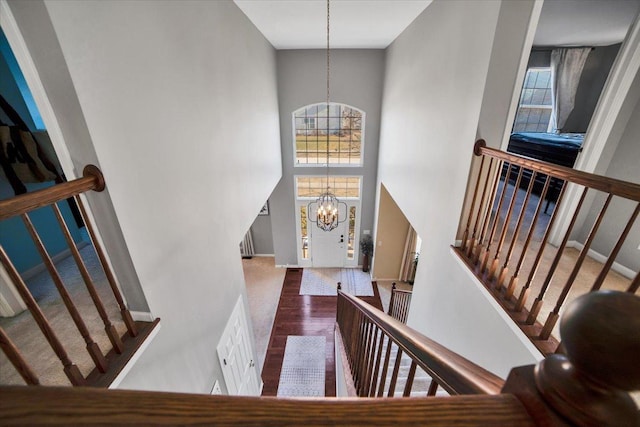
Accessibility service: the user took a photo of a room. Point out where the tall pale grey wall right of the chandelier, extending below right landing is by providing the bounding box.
[378,0,537,376]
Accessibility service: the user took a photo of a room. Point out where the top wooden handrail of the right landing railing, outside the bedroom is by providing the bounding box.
[473,139,640,202]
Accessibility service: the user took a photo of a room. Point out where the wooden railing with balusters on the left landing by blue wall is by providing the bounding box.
[0,165,157,386]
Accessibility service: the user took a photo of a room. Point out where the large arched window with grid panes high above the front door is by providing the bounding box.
[293,102,365,166]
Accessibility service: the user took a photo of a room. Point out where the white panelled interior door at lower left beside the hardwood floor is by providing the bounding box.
[218,296,260,396]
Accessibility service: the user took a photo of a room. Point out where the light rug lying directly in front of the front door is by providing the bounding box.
[300,268,373,297]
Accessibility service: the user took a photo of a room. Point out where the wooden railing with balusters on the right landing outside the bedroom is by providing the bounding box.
[455,140,640,354]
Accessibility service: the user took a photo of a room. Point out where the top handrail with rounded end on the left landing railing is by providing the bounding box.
[0,165,105,221]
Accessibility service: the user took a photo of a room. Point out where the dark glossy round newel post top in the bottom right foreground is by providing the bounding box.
[532,291,640,426]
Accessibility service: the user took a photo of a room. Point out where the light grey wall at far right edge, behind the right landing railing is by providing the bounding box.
[576,88,640,272]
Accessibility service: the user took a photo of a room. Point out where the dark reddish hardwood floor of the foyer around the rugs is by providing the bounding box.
[262,268,382,396]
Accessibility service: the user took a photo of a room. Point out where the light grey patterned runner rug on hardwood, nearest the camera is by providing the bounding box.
[278,335,326,397]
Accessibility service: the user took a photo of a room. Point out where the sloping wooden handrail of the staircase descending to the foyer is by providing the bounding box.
[338,291,504,394]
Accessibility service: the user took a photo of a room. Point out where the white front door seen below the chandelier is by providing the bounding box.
[310,221,347,267]
